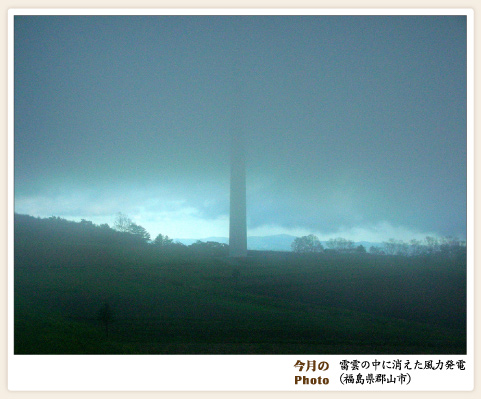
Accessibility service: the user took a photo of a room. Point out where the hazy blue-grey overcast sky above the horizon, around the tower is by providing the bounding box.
[14,12,467,240]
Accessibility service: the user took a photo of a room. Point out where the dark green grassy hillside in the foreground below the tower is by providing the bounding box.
[14,215,466,354]
